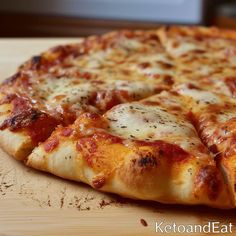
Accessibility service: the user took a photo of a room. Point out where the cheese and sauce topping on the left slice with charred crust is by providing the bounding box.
[26,74,159,116]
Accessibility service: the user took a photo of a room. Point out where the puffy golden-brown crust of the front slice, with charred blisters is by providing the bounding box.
[27,113,233,208]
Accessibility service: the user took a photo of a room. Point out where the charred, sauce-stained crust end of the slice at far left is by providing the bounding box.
[0,91,58,159]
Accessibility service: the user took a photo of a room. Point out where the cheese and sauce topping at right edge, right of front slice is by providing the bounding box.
[179,84,236,157]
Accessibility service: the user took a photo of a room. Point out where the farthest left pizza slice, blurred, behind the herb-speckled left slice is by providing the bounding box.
[20,30,175,86]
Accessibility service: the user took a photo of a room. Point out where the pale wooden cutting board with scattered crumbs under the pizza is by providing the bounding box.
[0,39,236,236]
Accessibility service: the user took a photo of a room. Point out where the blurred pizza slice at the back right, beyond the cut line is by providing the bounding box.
[159,26,236,96]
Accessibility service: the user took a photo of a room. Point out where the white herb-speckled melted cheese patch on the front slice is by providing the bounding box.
[105,103,203,150]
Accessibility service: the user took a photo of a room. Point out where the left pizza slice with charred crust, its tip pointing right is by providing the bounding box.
[0,75,158,159]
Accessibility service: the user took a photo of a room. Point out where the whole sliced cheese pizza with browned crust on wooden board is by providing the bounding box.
[0,26,236,209]
